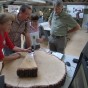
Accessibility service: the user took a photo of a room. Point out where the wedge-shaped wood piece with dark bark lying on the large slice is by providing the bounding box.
[17,53,38,77]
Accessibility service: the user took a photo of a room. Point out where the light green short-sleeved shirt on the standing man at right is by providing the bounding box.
[49,11,77,36]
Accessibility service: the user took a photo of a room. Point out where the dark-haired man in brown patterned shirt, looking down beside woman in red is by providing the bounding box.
[4,5,32,55]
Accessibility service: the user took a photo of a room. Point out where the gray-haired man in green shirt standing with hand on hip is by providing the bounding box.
[49,0,80,53]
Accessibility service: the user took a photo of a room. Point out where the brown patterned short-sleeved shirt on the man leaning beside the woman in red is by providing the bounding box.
[9,16,28,47]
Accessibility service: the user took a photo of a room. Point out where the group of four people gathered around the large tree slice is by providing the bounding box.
[0,1,80,61]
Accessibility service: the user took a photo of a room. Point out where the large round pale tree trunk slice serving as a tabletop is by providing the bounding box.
[2,50,66,88]
